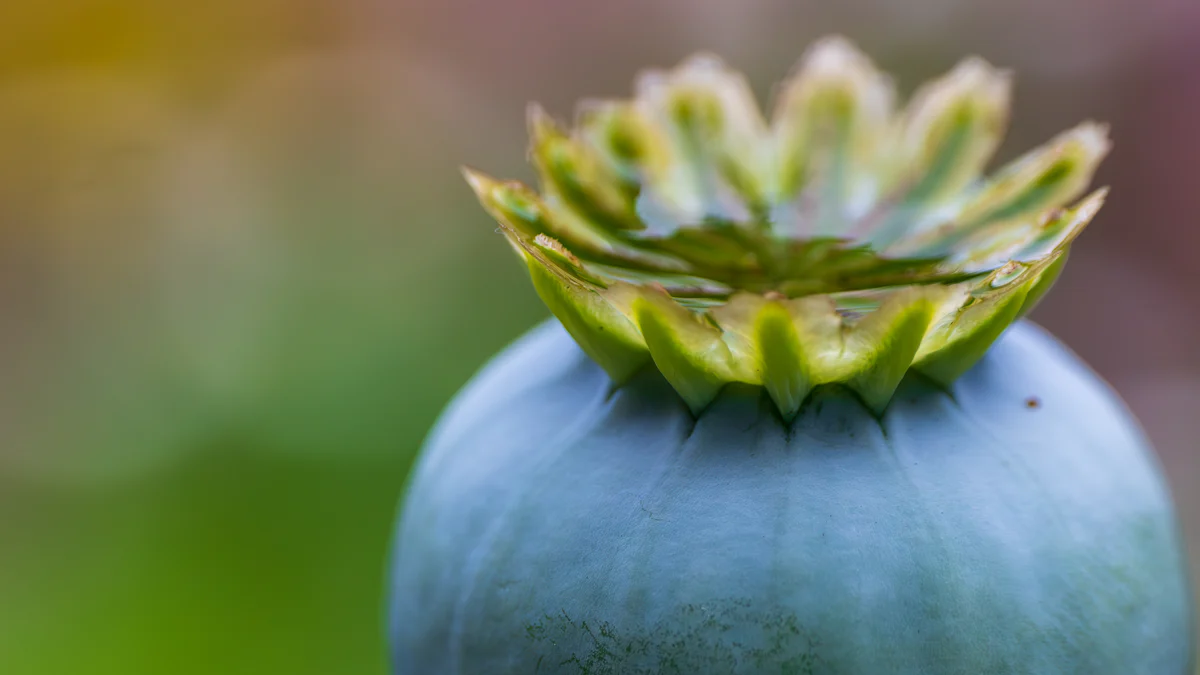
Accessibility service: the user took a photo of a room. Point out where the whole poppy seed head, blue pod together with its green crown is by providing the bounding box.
[390,38,1194,675]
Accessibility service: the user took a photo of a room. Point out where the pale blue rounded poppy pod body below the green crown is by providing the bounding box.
[390,323,1193,675]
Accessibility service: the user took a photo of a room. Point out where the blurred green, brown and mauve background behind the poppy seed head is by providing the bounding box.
[0,0,1200,675]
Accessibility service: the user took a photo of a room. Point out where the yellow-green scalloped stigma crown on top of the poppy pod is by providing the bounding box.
[467,37,1109,418]
